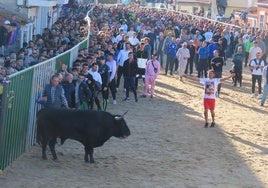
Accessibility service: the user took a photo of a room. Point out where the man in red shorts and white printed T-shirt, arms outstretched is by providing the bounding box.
[184,70,235,128]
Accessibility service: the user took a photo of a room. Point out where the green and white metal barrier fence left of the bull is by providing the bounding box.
[0,38,88,170]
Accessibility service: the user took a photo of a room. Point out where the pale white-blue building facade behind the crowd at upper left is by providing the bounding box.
[0,0,68,47]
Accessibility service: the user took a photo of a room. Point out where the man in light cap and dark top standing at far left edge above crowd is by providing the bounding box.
[0,20,11,55]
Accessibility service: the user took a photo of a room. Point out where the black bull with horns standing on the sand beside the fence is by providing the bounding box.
[37,109,130,163]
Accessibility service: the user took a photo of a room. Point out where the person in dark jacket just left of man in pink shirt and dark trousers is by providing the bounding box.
[98,56,110,111]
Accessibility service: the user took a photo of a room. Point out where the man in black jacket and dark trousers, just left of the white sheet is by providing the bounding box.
[123,52,138,102]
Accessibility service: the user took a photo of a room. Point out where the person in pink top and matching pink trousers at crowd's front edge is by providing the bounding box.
[142,54,161,98]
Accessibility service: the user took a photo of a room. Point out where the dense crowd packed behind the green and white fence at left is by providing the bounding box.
[0,3,90,109]
